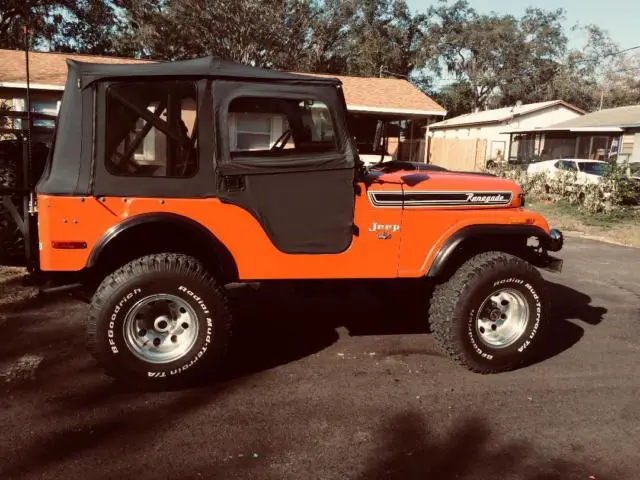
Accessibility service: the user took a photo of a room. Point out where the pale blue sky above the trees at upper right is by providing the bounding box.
[407,0,640,49]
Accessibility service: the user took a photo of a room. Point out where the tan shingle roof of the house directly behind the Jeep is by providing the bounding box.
[0,49,446,116]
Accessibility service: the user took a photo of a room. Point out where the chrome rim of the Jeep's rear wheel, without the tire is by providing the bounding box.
[123,294,199,363]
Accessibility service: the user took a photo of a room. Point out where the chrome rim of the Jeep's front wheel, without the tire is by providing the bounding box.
[476,288,529,348]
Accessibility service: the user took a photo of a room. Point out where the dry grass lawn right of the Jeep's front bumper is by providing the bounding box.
[527,200,640,247]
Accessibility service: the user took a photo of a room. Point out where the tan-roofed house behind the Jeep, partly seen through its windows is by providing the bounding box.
[0,49,446,161]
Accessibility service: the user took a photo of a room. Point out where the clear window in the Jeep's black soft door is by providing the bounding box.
[228,97,337,158]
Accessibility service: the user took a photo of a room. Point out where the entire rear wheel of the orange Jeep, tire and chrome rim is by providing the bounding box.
[87,254,231,383]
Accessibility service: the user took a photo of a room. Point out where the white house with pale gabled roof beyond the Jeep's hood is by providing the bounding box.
[429,100,585,167]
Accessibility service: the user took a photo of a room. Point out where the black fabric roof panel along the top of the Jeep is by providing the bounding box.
[67,57,340,88]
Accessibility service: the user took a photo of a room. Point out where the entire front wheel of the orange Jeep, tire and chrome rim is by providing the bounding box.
[430,252,548,373]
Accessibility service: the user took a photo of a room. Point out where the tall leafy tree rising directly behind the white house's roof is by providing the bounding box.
[430,0,567,109]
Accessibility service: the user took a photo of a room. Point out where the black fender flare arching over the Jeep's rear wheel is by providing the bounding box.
[86,212,235,278]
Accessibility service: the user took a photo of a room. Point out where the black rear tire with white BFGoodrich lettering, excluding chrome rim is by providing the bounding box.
[86,253,231,385]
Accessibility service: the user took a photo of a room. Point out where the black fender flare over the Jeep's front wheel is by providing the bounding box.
[427,224,559,277]
